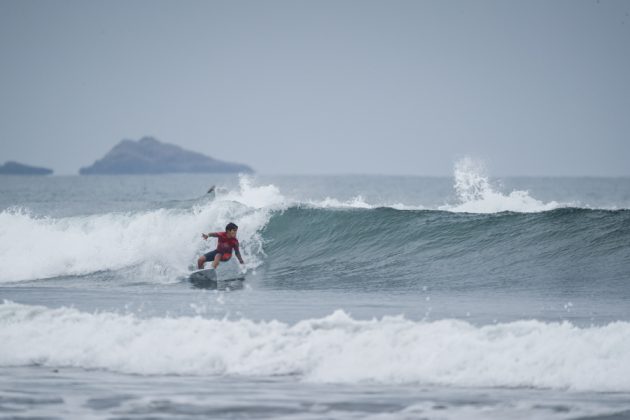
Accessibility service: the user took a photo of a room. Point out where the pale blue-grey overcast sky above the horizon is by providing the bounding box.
[0,0,630,176]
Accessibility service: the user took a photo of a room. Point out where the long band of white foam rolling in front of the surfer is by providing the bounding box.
[0,302,630,392]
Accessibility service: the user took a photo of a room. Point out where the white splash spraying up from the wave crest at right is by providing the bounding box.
[439,157,563,213]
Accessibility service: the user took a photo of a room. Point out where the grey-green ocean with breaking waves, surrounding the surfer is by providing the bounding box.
[0,159,630,420]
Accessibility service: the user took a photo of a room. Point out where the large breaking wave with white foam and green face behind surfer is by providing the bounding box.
[0,159,630,288]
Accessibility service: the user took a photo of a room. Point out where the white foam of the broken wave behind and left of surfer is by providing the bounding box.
[0,178,278,282]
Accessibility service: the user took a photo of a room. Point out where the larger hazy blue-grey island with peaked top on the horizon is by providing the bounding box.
[79,137,253,175]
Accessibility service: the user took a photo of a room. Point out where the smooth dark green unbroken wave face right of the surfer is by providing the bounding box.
[263,208,630,295]
